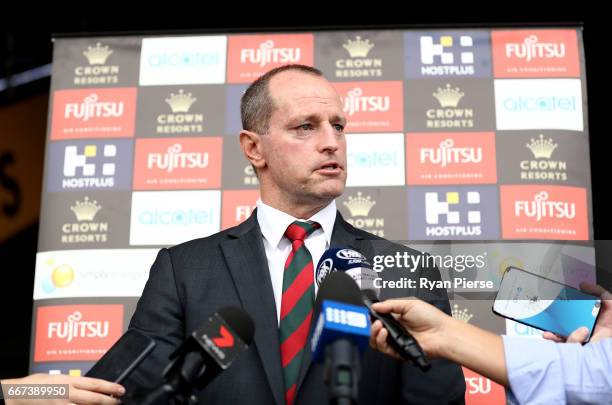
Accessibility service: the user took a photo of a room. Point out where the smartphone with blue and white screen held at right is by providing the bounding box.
[493,267,601,339]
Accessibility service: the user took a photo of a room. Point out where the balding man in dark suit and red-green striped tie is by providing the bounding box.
[126,65,465,405]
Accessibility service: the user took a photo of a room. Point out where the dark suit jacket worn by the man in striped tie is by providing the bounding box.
[125,213,465,405]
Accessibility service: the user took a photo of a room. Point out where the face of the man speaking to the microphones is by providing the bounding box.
[261,71,346,205]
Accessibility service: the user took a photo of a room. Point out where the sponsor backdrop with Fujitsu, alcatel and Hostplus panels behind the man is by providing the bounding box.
[37,27,594,403]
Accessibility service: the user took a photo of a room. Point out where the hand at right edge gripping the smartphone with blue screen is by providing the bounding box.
[544,282,612,343]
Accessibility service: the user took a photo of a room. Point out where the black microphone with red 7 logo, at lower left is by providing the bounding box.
[142,307,255,405]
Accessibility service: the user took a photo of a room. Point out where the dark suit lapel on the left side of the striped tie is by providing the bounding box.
[221,211,285,405]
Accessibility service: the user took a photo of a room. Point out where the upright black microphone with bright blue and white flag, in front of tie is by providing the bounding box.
[311,272,370,405]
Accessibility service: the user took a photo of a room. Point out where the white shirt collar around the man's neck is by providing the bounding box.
[257,199,336,248]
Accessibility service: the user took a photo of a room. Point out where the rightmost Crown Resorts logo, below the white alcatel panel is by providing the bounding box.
[519,134,567,181]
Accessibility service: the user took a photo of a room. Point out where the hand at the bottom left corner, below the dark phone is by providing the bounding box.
[2,374,125,405]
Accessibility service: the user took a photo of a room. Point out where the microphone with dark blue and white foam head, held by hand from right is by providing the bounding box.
[316,248,431,371]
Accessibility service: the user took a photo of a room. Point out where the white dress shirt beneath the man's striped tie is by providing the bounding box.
[257,200,336,323]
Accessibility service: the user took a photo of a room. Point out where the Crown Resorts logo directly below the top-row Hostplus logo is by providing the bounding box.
[425,83,474,129]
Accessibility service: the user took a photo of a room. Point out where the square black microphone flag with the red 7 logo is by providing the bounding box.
[193,313,248,370]
